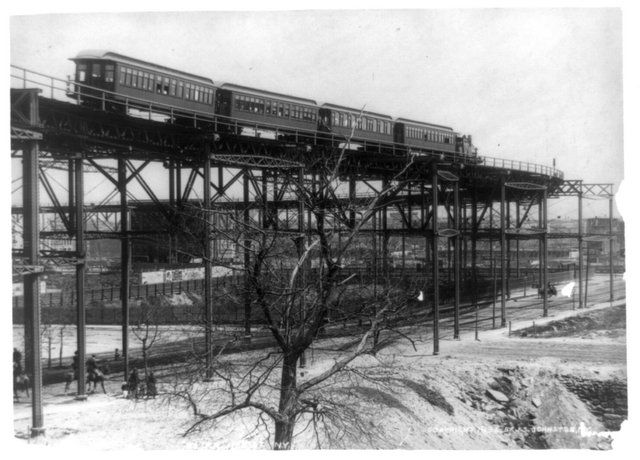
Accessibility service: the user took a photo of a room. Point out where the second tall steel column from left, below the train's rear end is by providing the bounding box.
[73,156,87,400]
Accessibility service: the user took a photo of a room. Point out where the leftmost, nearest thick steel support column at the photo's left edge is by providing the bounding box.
[22,132,44,437]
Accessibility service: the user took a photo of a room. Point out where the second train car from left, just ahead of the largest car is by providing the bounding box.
[215,83,318,137]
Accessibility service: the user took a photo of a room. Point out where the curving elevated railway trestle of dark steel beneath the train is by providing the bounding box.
[11,67,613,435]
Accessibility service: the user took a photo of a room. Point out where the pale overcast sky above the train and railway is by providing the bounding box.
[10,8,623,217]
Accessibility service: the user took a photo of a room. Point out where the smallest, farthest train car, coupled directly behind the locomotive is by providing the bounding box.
[393,118,457,153]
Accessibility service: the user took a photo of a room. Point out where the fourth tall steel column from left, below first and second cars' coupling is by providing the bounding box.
[202,144,213,379]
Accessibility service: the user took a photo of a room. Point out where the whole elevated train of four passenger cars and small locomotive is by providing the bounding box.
[69,50,477,157]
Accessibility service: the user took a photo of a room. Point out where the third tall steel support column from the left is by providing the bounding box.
[118,158,131,380]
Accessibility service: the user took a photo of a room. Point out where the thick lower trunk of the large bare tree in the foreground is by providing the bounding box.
[274,353,298,450]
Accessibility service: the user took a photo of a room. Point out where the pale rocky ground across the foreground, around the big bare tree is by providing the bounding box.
[14,286,627,449]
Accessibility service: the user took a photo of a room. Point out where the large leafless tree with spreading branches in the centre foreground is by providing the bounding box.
[162,137,412,449]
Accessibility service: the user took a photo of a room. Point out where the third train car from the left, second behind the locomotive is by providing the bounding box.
[318,104,393,144]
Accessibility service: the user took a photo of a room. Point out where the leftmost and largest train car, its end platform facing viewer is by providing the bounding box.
[70,50,215,114]
